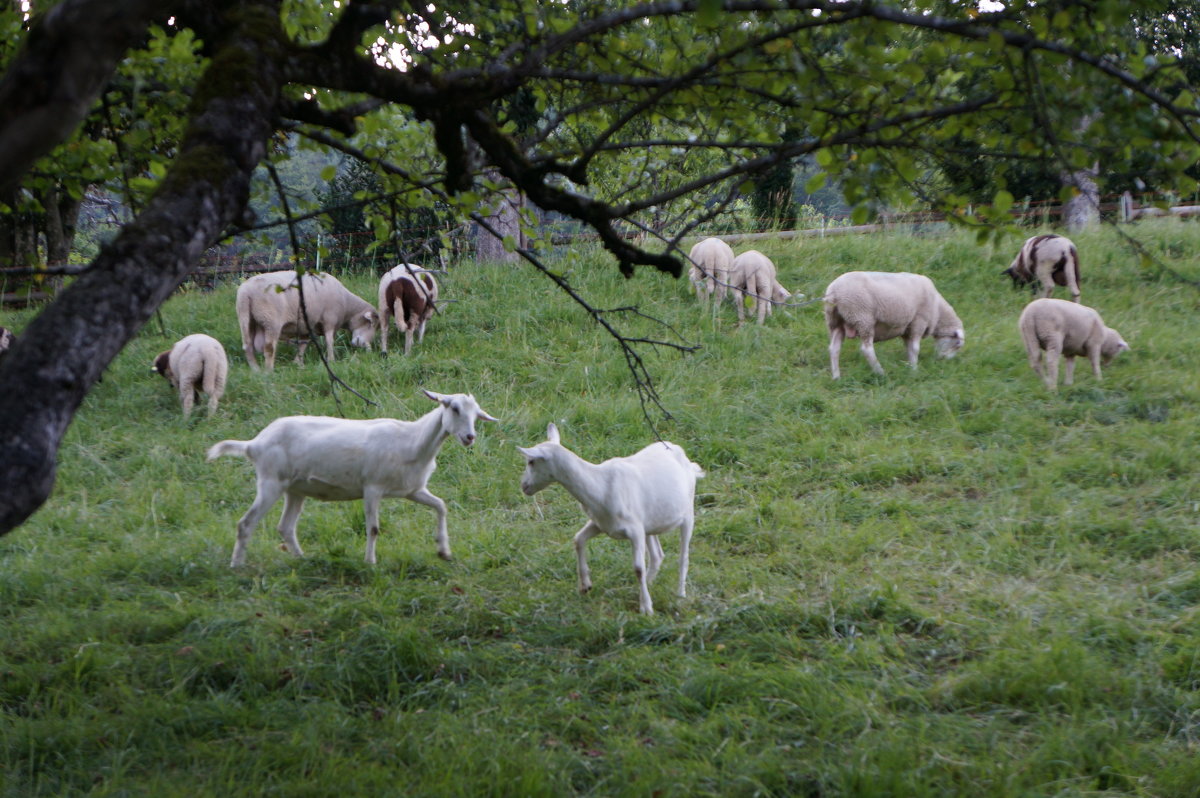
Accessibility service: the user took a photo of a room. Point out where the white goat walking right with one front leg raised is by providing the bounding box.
[208,391,497,568]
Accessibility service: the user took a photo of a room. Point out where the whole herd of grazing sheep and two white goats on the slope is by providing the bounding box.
[0,226,1129,614]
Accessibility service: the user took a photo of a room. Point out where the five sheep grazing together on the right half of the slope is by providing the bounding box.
[689,234,1129,390]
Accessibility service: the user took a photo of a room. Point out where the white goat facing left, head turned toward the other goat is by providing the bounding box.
[517,424,704,616]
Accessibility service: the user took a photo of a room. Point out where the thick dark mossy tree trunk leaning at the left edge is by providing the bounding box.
[0,0,283,534]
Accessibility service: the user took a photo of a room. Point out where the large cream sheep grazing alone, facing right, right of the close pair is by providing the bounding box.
[824,271,966,379]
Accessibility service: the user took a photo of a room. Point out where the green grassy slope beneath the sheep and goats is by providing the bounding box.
[0,222,1200,797]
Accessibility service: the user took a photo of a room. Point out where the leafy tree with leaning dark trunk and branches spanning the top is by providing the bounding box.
[0,0,1200,533]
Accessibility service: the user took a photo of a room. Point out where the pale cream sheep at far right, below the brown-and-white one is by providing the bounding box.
[1016,298,1129,391]
